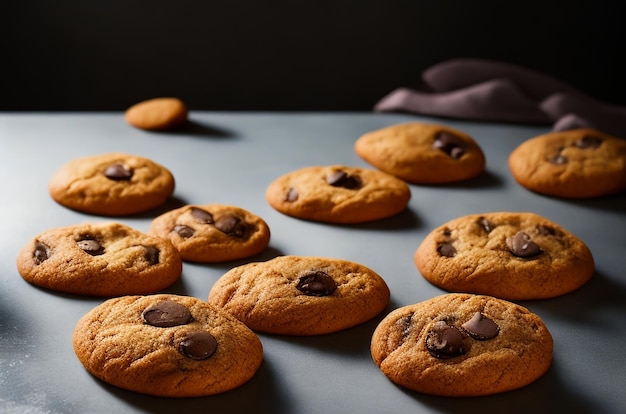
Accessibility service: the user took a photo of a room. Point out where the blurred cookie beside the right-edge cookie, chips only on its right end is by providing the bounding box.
[354,122,485,184]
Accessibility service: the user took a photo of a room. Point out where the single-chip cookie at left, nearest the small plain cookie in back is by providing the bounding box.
[48,153,175,216]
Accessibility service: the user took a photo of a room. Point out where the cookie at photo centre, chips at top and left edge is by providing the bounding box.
[265,165,411,224]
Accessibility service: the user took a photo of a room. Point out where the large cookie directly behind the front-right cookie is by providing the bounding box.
[414,212,594,300]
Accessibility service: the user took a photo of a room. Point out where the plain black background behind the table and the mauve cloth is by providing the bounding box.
[0,0,626,111]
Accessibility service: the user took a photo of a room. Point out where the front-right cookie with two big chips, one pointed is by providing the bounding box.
[371,293,553,397]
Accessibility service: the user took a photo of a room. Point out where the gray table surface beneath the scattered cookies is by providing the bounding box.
[0,112,626,414]
